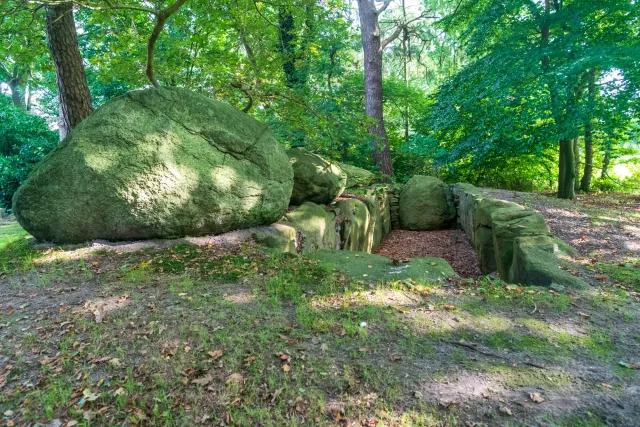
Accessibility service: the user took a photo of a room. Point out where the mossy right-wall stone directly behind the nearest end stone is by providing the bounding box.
[491,206,550,279]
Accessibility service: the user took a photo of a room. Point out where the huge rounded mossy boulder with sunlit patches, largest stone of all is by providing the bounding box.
[13,88,293,243]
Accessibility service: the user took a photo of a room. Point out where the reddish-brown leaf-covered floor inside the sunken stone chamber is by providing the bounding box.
[376,230,482,277]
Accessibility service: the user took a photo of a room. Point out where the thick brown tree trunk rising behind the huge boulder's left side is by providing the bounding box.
[46,3,93,140]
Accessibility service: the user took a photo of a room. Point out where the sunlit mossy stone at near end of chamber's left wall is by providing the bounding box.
[279,202,340,252]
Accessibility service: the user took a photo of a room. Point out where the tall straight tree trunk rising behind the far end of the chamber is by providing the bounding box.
[358,0,393,178]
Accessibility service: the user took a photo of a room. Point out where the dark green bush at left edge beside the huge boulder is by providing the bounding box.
[0,96,57,209]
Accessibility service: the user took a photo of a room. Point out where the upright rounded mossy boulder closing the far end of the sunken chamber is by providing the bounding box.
[399,175,456,230]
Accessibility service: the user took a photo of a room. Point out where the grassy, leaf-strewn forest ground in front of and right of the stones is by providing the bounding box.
[0,192,640,426]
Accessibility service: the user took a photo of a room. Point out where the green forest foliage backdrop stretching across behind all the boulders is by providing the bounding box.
[0,0,640,209]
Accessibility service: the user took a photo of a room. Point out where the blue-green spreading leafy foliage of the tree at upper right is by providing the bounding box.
[420,0,640,189]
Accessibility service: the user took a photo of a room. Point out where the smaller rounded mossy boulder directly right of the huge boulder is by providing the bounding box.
[287,148,347,205]
